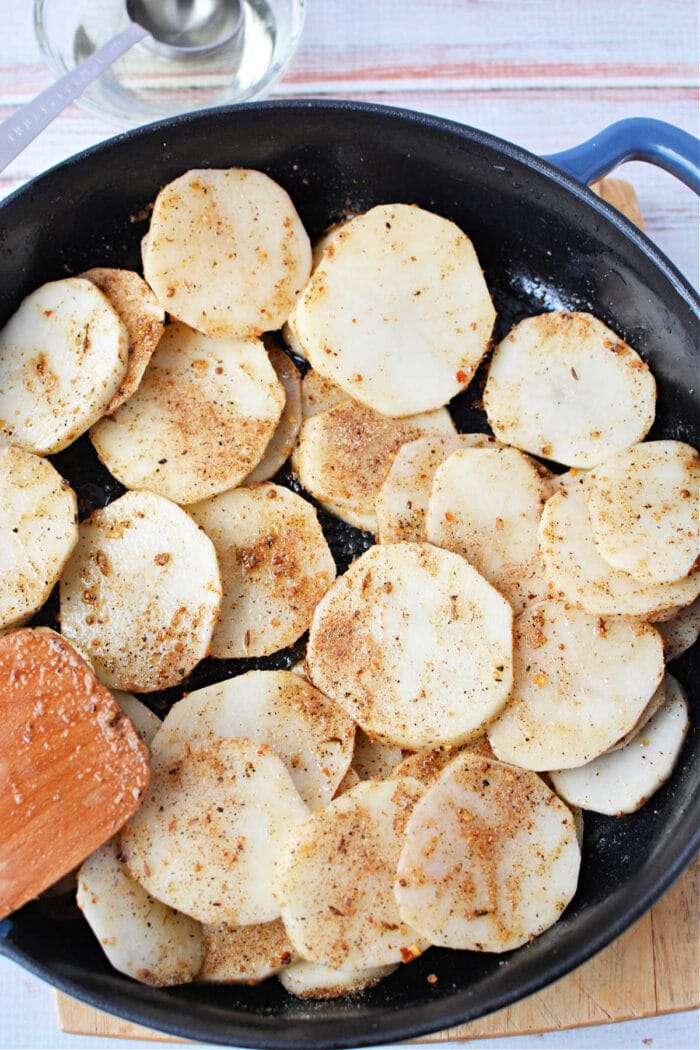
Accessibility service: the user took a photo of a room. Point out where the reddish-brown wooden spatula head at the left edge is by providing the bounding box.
[0,628,149,918]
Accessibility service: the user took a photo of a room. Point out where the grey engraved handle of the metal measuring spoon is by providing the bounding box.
[0,22,148,171]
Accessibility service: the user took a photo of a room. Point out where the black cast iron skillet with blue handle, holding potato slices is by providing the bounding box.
[0,101,700,1048]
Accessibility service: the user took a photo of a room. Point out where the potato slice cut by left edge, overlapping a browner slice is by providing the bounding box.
[0,277,128,455]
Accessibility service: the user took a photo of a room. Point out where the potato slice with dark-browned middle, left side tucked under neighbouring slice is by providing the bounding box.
[188,483,336,659]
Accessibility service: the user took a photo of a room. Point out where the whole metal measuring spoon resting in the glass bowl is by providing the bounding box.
[0,0,243,171]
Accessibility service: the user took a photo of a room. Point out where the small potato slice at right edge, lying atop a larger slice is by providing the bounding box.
[588,441,700,584]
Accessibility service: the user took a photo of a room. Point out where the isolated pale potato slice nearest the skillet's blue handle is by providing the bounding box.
[484,312,656,467]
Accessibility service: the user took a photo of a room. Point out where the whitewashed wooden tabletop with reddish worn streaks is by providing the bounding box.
[0,0,700,1050]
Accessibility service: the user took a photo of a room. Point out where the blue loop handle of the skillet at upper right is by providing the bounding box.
[544,117,700,195]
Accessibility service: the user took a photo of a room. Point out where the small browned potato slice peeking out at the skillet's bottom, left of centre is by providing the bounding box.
[197,919,297,985]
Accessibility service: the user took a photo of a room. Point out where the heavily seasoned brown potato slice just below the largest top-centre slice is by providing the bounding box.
[292,400,455,531]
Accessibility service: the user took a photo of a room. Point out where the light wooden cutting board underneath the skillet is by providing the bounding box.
[57,179,700,1043]
